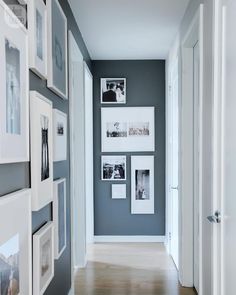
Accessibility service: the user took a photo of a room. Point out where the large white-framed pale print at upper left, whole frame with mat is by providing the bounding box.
[0,0,29,164]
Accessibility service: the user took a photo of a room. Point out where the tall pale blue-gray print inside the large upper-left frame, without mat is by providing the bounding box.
[5,39,21,134]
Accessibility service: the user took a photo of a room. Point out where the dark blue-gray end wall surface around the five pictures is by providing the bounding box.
[92,60,165,235]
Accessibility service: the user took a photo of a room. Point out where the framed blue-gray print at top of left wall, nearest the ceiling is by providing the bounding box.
[47,0,68,99]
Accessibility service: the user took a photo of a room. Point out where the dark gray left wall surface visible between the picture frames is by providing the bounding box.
[0,0,91,295]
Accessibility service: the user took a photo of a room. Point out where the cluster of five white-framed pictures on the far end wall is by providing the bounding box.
[101,78,155,214]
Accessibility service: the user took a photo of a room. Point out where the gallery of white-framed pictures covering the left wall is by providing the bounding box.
[0,0,68,295]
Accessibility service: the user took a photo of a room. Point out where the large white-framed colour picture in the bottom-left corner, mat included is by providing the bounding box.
[0,189,32,295]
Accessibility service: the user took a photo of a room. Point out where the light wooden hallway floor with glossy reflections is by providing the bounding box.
[75,243,196,295]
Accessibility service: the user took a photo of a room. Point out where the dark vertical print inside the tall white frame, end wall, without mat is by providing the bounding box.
[135,170,150,200]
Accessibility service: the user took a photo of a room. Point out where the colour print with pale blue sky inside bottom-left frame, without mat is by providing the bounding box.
[0,234,20,295]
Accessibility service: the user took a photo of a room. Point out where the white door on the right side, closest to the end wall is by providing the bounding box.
[170,59,179,269]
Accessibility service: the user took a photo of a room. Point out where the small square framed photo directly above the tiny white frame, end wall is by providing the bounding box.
[101,156,126,181]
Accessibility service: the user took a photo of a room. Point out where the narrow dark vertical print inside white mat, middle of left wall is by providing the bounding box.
[41,115,49,181]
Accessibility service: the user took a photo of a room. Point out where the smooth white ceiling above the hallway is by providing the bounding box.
[68,0,189,60]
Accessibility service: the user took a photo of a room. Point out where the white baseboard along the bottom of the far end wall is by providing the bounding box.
[94,236,165,243]
